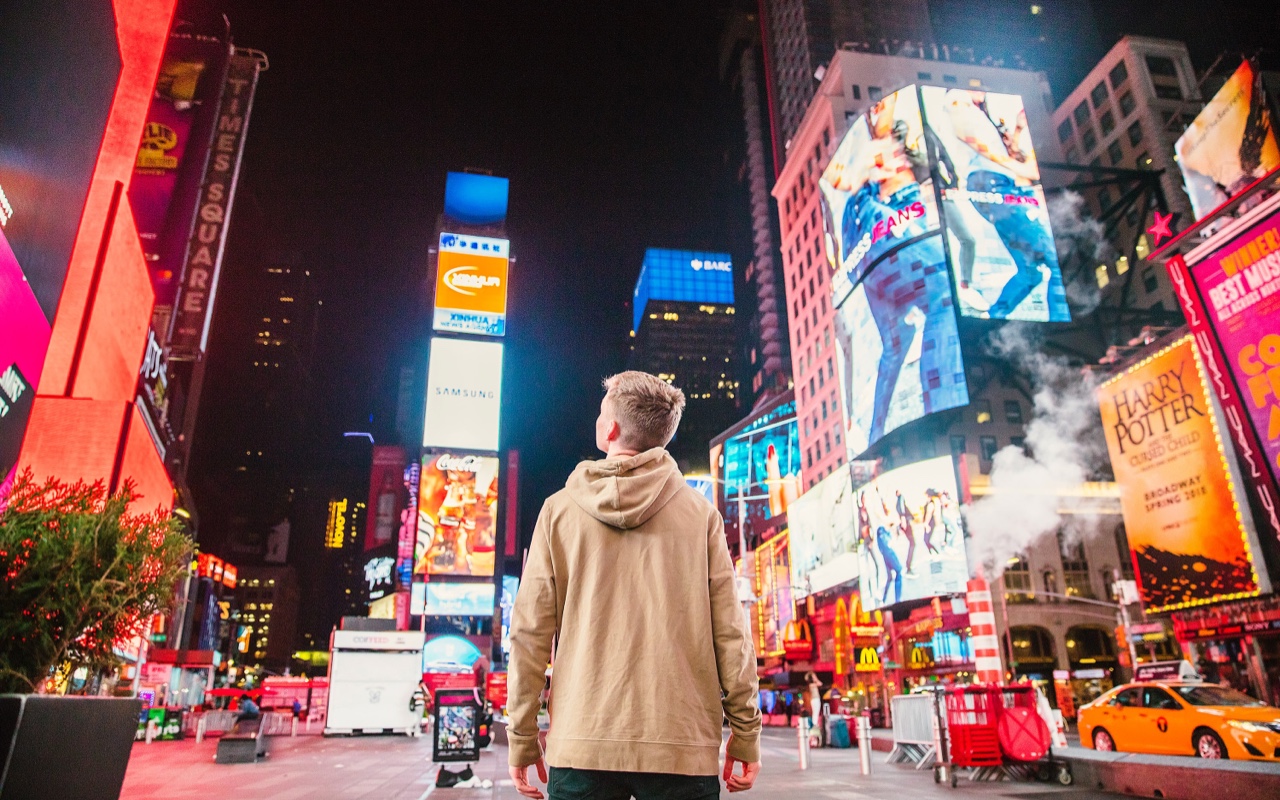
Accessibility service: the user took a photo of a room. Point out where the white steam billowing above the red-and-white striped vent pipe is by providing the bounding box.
[964,321,1107,580]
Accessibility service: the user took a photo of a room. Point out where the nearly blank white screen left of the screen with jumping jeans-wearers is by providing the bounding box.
[787,463,858,600]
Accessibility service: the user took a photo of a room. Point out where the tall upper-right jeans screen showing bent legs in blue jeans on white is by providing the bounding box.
[920,86,1071,323]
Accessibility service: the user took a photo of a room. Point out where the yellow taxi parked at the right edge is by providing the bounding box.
[1078,680,1280,762]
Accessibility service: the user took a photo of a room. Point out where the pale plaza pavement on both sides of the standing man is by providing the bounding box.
[120,728,1119,800]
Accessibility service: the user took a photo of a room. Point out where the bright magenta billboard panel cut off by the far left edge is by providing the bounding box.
[0,230,50,493]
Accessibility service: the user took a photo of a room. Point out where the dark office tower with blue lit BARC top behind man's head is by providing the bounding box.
[627,247,741,472]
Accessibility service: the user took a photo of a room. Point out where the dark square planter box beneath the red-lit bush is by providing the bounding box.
[0,695,142,800]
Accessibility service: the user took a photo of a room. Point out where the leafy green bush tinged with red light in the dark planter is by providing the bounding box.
[0,470,192,692]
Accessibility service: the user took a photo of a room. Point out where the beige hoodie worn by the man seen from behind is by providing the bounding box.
[507,448,760,776]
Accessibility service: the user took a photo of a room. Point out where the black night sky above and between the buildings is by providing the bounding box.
[179,0,1280,537]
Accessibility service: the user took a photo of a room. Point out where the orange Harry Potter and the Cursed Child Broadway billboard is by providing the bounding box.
[1098,337,1263,612]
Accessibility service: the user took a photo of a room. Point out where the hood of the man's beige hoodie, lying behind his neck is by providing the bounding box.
[564,447,685,530]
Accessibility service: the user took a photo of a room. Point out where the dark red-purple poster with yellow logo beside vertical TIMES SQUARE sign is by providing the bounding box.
[129,36,228,311]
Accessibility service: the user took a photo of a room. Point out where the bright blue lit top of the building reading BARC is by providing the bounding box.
[631,247,733,330]
